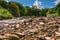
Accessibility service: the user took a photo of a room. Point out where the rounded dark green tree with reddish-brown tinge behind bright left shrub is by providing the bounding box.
[8,2,20,17]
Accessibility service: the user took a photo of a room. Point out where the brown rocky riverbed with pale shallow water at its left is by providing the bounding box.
[0,17,60,40]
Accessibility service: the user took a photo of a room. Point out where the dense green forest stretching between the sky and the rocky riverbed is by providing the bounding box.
[0,0,60,19]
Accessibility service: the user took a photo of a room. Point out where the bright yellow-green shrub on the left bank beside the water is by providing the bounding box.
[0,7,13,19]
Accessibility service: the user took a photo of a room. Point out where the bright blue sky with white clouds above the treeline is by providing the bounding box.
[6,0,60,8]
